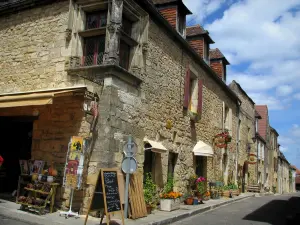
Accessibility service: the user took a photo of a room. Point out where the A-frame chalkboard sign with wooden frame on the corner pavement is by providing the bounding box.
[84,169,124,225]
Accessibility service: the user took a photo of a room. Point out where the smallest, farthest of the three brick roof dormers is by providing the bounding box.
[209,48,230,82]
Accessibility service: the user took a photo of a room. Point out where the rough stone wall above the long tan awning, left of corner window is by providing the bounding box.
[0,1,91,93]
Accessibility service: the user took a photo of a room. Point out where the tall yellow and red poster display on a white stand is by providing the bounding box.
[63,136,85,189]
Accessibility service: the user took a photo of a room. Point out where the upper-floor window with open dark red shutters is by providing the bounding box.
[183,67,203,120]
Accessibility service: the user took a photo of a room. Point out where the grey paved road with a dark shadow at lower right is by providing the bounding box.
[173,193,300,225]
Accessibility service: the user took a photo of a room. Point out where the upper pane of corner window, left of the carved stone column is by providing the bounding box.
[85,11,107,30]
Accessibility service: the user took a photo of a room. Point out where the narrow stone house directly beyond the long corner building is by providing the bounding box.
[229,81,261,190]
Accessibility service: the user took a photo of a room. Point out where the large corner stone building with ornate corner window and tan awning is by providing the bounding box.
[0,0,240,212]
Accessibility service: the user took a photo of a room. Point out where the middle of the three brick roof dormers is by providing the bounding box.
[186,24,215,65]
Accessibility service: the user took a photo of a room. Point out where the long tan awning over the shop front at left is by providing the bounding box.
[0,87,86,108]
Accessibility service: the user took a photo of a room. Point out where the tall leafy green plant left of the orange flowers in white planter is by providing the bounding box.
[144,173,157,214]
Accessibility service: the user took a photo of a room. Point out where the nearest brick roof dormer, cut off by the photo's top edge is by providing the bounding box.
[152,0,192,38]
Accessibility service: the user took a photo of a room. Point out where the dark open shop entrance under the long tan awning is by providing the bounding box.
[0,117,35,200]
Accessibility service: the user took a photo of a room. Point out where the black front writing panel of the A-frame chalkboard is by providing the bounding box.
[101,170,121,212]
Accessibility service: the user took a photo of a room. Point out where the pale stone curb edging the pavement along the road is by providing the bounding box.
[142,194,255,225]
